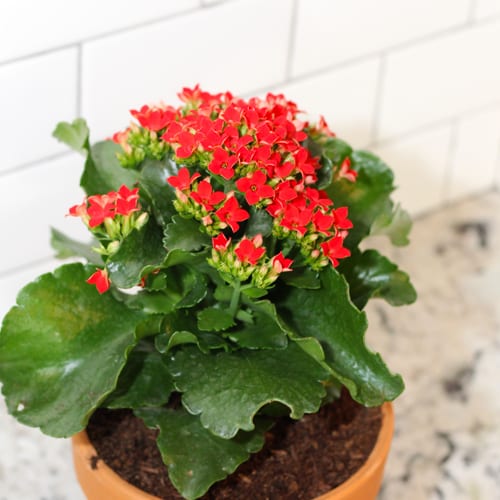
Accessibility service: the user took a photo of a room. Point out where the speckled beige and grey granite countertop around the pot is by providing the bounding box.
[0,193,500,500]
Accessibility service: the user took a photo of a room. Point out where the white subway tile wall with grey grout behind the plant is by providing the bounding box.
[0,0,500,316]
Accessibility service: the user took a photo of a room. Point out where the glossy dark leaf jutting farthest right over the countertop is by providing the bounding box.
[340,250,417,309]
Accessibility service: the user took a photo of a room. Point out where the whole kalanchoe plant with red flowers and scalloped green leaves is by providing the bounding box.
[0,87,415,498]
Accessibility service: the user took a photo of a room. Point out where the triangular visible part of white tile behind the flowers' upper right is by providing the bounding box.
[277,60,379,147]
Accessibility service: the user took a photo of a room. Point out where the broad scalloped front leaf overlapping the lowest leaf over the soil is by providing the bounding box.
[170,342,329,438]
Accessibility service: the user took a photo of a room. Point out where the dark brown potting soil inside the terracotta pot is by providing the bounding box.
[87,393,381,500]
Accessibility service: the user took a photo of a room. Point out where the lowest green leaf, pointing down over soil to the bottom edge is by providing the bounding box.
[135,408,269,500]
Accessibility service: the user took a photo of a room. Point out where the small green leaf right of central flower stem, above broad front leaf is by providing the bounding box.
[229,300,288,349]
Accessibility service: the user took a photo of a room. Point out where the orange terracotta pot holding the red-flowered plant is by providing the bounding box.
[73,403,394,500]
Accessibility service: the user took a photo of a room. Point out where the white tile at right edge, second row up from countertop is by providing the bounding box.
[379,22,500,137]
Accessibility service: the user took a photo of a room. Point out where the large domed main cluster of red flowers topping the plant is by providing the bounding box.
[114,86,356,287]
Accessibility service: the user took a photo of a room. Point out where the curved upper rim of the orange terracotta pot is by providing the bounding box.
[71,402,394,500]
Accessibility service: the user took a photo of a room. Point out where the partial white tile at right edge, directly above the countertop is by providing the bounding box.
[447,108,500,200]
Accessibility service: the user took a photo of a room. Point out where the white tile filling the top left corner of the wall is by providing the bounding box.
[0,0,199,62]
